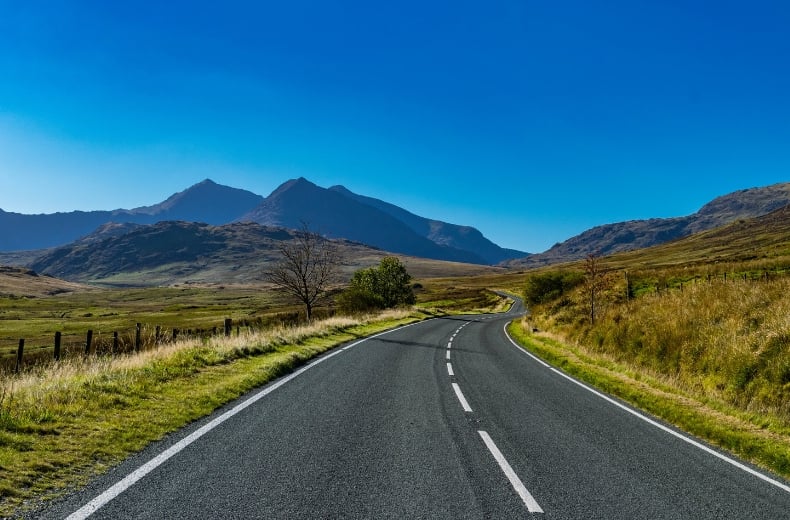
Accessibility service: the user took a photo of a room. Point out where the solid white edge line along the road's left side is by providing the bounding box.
[67,320,430,520]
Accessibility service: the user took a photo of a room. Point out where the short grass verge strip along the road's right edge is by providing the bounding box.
[508,321,790,479]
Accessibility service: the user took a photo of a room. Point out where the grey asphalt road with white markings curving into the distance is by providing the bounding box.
[42,298,790,520]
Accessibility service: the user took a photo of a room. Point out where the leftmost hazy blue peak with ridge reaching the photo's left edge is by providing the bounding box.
[0,179,263,251]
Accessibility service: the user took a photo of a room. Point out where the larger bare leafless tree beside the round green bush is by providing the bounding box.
[264,223,340,321]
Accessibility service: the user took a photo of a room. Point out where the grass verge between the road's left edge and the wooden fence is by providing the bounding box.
[0,311,431,517]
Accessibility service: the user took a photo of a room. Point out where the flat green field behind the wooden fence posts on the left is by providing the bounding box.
[0,286,300,359]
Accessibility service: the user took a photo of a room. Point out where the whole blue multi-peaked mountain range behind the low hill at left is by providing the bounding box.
[0,178,527,265]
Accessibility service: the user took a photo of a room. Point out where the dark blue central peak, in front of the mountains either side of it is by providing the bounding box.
[239,178,488,264]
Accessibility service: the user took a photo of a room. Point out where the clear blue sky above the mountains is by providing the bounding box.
[0,0,790,252]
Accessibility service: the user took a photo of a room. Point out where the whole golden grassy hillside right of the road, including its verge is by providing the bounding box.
[510,207,790,476]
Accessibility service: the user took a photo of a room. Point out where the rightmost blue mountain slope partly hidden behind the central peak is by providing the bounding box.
[329,186,528,265]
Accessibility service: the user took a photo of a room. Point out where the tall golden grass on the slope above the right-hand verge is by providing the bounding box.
[532,273,790,424]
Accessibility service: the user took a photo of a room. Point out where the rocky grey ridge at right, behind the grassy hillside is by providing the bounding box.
[507,183,790,267]
